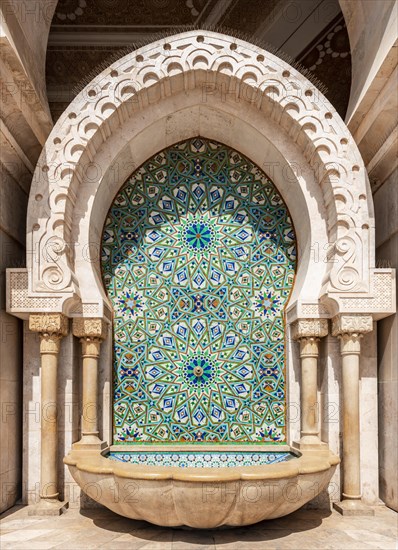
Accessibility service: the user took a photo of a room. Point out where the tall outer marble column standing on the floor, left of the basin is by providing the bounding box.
[29,313,68,515]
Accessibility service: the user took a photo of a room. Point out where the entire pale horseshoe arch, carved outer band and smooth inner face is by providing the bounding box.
[8,31,394,321]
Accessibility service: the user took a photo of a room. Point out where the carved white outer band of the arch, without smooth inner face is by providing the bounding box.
[7,31,394,322]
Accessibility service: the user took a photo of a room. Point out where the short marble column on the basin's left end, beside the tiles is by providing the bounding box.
[73,318,107,450]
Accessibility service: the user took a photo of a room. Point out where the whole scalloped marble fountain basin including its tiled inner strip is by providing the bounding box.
[64,445,339,529]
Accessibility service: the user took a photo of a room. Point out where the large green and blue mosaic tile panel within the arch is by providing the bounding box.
[102,138,296,444]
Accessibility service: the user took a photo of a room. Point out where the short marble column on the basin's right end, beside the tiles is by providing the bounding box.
[292,319,328,450]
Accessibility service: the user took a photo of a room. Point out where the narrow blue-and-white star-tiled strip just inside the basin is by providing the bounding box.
[108,451,295,468]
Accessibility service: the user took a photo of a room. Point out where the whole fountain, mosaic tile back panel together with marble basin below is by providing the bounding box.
[65,137,338,528]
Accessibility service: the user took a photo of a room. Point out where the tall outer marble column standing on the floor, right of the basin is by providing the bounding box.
[333,315,374,515]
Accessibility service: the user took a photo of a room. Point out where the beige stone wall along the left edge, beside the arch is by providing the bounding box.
[0,0,56,512]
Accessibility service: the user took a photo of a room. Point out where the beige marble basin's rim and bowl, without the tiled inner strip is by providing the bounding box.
[64,447,339,529]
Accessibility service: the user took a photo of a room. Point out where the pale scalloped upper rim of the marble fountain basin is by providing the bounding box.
[64,448,340,483]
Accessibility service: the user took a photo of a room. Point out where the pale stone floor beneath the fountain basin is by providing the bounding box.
[0,506,398,550]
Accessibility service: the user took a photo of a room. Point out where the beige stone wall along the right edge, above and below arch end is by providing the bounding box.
[340,0,398,510]
